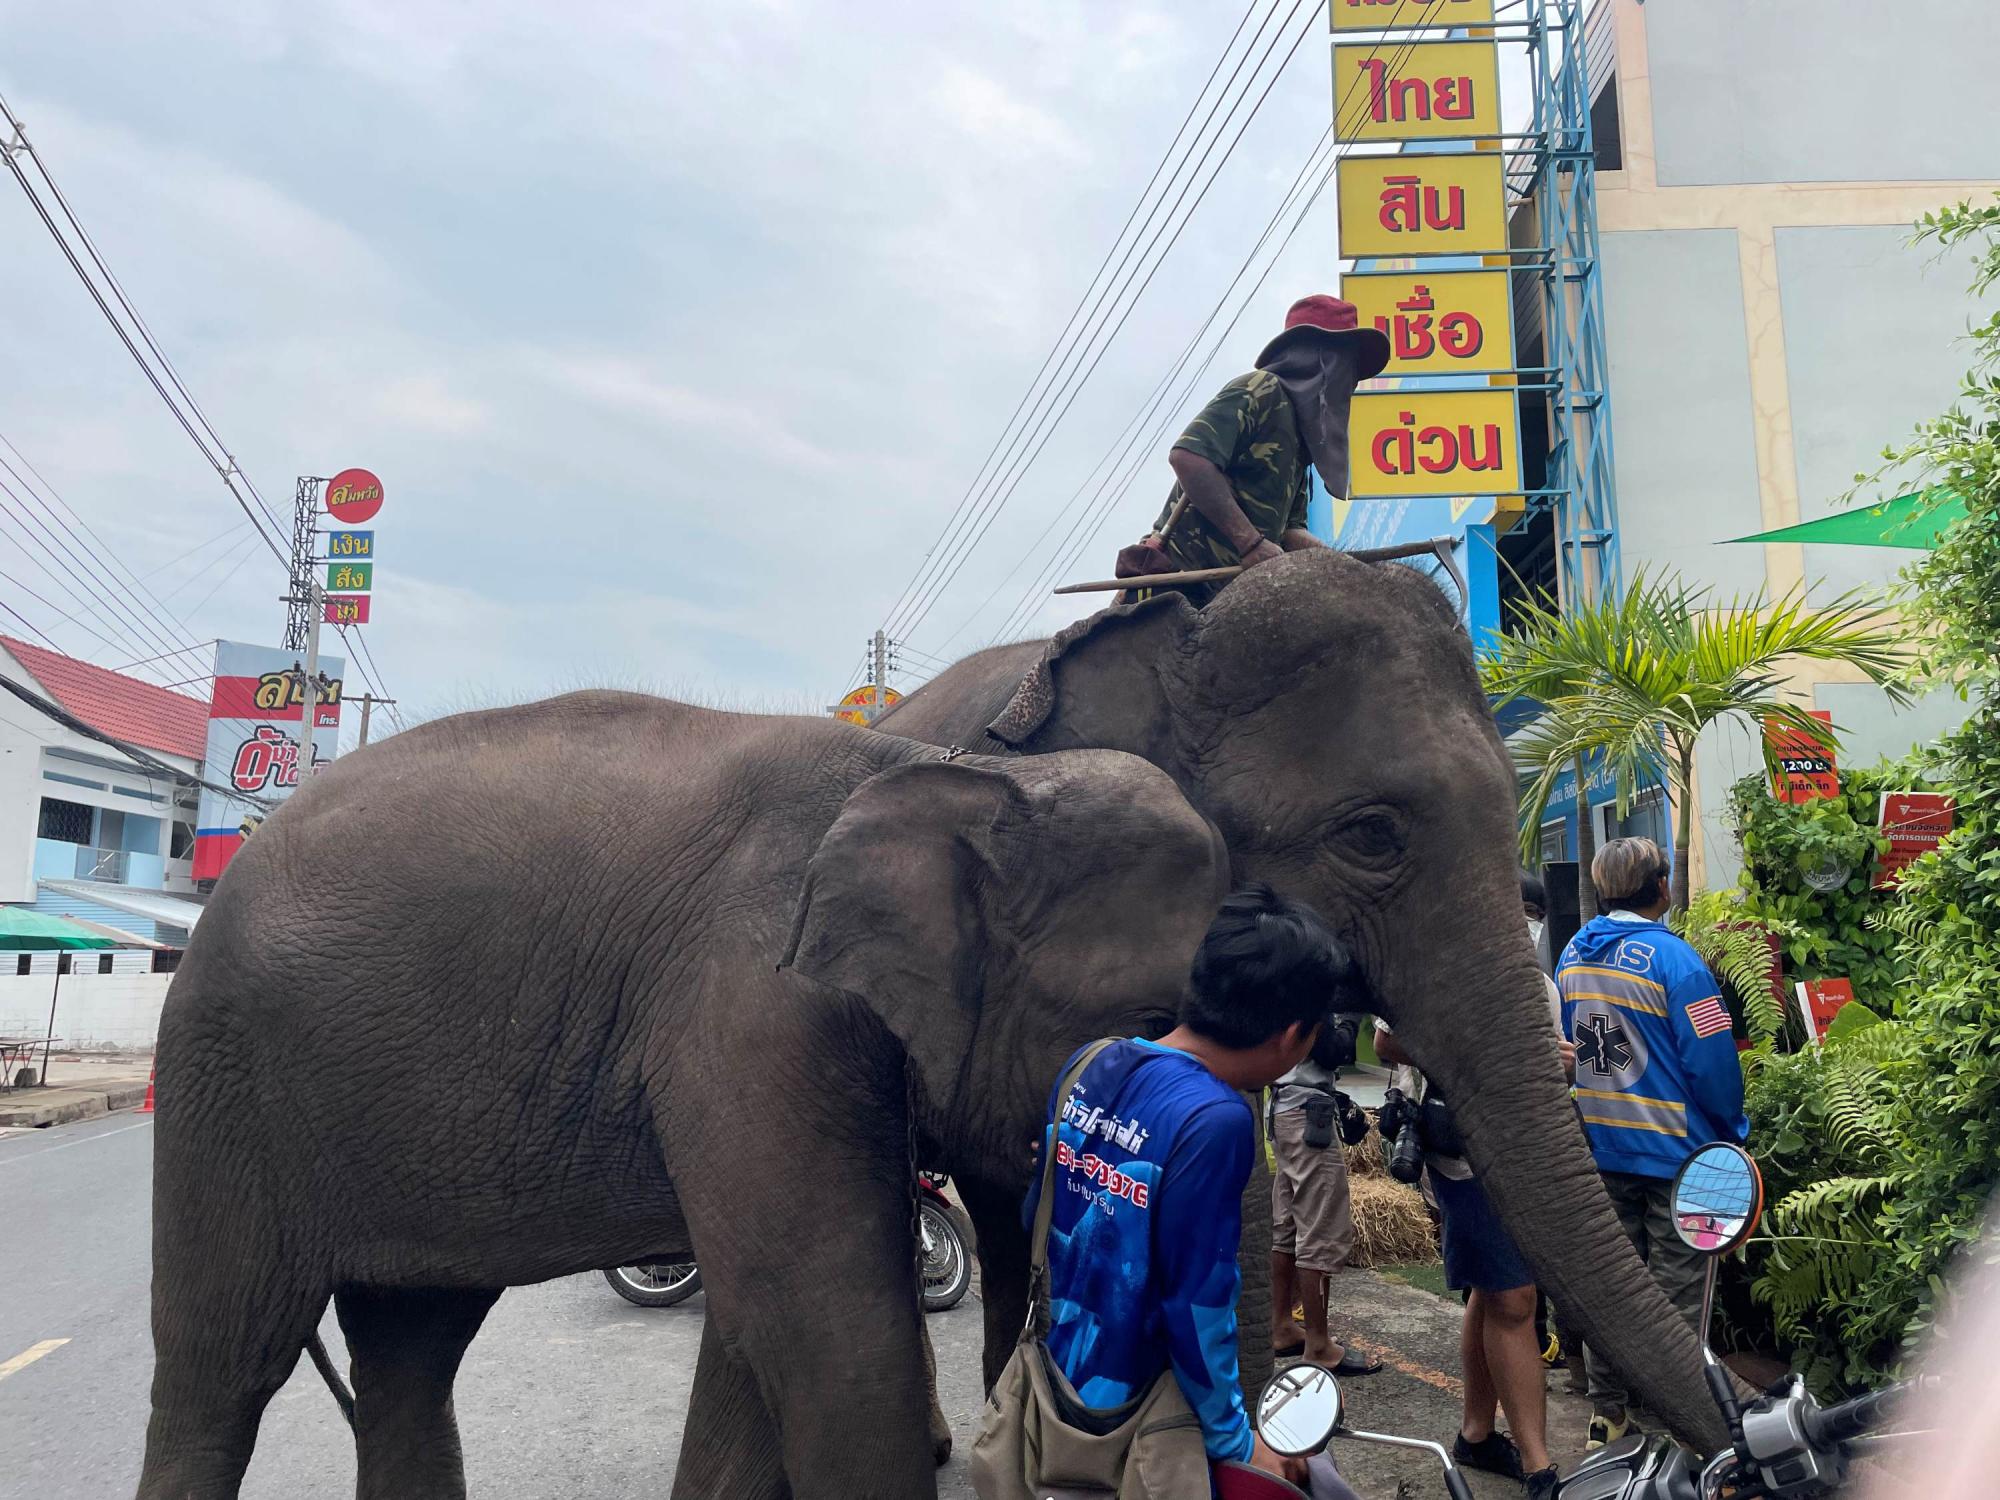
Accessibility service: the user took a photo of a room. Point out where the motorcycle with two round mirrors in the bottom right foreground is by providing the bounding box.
[1216,1142,1934,1500]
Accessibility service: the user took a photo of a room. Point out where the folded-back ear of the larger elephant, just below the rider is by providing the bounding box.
[986,592,1202,764]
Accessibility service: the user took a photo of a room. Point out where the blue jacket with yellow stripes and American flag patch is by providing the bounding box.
[1556,912,1750,1178]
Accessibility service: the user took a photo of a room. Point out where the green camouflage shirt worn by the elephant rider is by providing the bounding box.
[1154,370,1310,568]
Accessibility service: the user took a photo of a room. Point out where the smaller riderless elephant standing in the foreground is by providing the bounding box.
[138,692,1228,1500]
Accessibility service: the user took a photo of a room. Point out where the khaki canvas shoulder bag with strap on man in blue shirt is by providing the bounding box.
[970,1038,1210,1500]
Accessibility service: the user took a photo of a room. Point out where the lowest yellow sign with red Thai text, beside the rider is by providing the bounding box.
[1348,390,1520,500]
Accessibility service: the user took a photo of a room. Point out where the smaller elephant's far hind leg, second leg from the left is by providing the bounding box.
[334,1286,500,1500]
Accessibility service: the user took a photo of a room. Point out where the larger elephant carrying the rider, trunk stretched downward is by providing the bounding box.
[878,550,1726,1452]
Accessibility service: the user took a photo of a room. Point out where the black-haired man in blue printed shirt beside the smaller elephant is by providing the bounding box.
[1022,886,1356,1484]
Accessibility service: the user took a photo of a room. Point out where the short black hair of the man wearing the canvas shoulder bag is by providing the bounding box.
[1180,884,1358,1048]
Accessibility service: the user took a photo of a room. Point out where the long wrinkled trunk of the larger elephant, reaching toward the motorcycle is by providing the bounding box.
[1392,940,1728,1454]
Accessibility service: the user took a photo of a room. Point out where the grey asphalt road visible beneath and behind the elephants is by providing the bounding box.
[0,1112,1584,1500]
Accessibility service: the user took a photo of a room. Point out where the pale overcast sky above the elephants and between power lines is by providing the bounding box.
[0,0,1338,728]
